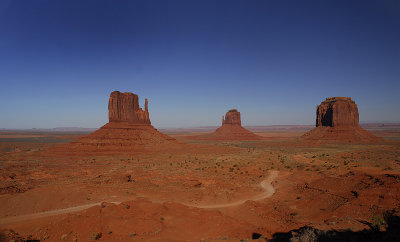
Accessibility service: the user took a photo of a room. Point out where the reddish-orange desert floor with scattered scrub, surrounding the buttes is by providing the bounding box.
[0,129,400,241]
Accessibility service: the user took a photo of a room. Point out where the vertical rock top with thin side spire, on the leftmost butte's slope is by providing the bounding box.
[108,91,151,124]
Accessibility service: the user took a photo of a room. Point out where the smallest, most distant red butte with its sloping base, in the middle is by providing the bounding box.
[212,109,262,140]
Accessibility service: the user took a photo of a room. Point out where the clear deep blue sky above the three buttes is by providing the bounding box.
[0,0,400,128]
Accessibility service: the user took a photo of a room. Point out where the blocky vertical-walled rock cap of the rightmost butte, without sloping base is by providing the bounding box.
[316,97,358,127]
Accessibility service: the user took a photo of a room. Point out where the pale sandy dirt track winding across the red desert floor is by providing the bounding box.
[0,171,278,225]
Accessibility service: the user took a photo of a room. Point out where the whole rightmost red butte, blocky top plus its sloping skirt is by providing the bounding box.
[302,97,381,144]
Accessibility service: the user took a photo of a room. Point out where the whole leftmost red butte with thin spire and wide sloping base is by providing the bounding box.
[52,91,181,152]
